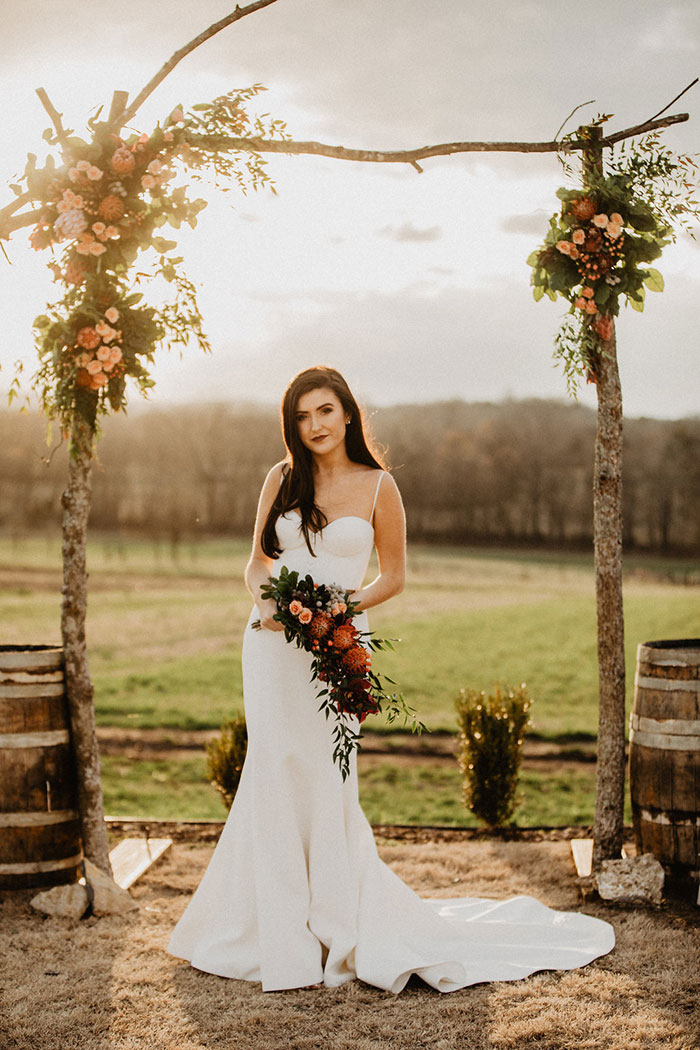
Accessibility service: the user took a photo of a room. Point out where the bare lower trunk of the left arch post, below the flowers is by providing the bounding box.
[61,413,111,875]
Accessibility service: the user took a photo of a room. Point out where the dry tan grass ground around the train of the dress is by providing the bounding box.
[0,840,700,1050]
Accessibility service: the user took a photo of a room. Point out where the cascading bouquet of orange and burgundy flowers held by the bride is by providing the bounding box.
[252,566,425,780]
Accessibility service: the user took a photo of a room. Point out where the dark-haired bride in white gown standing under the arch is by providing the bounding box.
[169,368,614,992]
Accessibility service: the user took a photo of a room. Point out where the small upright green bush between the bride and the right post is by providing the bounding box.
[455,685,531,827]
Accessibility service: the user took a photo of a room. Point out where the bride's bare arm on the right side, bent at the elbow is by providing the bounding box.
[353,474,406,610]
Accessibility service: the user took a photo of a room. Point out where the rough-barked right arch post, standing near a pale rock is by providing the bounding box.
[582,127,624,868]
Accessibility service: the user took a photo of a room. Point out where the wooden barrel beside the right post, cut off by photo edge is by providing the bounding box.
[630,638,700,880]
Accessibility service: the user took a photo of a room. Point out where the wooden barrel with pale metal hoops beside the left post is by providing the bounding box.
[0,646,82,889]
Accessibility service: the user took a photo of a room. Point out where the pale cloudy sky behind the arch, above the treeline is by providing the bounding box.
[0,0,700,418]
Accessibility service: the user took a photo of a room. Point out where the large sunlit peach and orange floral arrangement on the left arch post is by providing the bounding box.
[12,85,284,434]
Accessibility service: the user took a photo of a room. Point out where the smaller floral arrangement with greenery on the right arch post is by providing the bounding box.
[528,127,699,394]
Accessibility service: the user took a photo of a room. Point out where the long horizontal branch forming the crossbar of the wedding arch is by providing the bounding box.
[185,113,688,167]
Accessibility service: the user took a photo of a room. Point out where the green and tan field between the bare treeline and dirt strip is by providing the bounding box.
[0,537,700,737]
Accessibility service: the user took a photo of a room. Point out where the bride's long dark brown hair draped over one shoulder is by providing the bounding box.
[260,365,385,558]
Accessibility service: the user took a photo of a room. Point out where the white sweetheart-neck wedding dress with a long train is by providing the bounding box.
[168,479,614,992]
